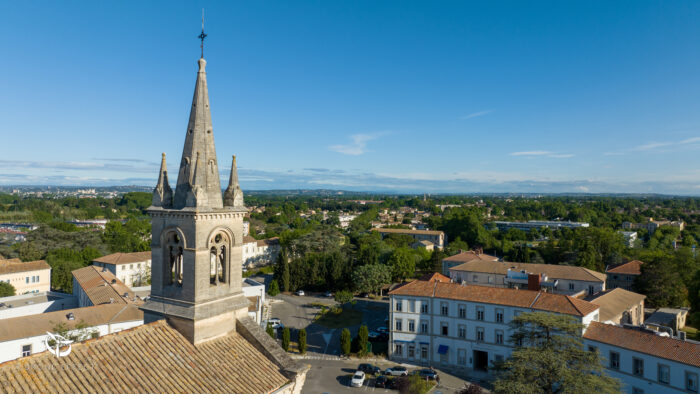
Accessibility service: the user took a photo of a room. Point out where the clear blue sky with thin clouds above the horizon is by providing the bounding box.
[0,0,700,195]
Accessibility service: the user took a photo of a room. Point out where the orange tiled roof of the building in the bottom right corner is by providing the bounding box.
[583,322,700,367]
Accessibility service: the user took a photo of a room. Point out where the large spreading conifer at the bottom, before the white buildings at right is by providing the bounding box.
[494,312,620,393]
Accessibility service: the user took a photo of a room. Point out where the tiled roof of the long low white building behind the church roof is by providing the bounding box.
[0,304,143,342]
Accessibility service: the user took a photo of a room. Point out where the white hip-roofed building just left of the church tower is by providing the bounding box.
[92,251,151,287]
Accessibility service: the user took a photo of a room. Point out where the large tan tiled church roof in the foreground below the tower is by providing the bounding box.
[0,320,288,394]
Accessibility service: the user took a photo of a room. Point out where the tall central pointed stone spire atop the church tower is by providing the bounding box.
[173,59,223,209]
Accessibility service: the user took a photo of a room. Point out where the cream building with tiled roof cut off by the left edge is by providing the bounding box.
[0,259,51,294]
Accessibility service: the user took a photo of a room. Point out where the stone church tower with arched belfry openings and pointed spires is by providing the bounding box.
[142,58,248,344]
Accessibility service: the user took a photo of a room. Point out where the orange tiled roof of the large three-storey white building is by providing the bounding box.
[389,280,598,316]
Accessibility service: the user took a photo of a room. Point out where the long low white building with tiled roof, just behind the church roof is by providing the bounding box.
[0,304,143,363]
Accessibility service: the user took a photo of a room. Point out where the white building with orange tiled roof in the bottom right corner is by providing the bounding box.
[583,322,700,394]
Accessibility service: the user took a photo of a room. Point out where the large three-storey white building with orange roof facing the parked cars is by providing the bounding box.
[388,274,600,373]
